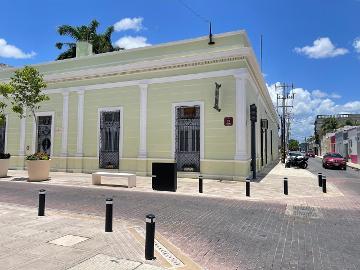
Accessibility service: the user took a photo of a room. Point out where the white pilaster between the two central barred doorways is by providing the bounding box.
[138,84,148,158]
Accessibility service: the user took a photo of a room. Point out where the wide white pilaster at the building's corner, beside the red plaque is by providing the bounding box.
[234,72,250,161]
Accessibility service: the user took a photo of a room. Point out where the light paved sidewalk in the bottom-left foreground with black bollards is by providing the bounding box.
[0,203,199,270]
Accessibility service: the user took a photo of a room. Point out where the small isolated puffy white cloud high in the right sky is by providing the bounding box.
[294,37,349,59]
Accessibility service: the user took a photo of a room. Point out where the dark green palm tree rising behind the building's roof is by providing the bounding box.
[56,20,122,60]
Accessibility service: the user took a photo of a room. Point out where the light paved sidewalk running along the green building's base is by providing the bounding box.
[0,163,342,200]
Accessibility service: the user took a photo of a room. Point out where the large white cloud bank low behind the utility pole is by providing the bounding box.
[268,83,360,141]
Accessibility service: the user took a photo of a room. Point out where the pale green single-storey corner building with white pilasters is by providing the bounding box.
[0,31,278,179]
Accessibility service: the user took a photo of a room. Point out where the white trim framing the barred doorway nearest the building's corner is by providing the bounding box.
[171,101,205,160]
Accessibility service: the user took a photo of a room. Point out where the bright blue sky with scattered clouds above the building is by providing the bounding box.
[0,0,360,138]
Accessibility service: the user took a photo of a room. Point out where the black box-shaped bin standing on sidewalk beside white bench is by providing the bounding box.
[152,162,177,192]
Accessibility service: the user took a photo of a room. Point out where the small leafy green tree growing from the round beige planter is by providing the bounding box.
[6,66,49,150]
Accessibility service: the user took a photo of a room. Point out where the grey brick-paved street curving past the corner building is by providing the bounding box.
[0,160,360,269]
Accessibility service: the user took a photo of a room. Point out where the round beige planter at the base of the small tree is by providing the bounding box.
[26,152,51,182]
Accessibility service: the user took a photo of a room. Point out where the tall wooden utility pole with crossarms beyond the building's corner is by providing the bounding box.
[275,83,294,163]
